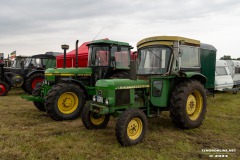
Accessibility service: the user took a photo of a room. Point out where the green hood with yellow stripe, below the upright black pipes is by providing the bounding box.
[45,68,92,77]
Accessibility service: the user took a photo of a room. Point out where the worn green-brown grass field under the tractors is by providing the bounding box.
[0,89,240,160]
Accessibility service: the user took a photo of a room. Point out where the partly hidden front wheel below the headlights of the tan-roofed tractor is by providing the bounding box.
[82,104,110,129]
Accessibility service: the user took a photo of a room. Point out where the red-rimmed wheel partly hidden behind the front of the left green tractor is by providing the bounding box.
[24,73,44,95]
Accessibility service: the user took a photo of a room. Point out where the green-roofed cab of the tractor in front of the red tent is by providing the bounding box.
[88,40,132,85]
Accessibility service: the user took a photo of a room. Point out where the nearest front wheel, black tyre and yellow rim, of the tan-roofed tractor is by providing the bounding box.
[115,108,147,146]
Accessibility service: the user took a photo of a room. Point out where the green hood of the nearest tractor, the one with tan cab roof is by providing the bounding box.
[96,79,149,90]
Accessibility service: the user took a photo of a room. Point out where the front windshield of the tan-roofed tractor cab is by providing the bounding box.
[138,46,171,74]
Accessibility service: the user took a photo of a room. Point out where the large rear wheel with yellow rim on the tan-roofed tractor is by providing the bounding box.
[170,80,206,129]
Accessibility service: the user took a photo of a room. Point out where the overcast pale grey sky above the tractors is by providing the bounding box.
[0,0,240,59]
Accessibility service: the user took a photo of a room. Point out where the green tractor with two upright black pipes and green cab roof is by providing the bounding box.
[23,39,132,120]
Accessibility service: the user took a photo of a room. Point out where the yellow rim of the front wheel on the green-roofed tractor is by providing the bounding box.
[58,92,79,114]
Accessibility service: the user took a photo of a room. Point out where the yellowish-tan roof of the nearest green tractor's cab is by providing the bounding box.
[137,36,200,48]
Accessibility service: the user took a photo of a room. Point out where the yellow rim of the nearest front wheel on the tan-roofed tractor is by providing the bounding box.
[127,118,143,140]
